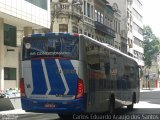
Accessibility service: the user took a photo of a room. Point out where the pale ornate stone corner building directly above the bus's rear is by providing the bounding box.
[51,0,95,38]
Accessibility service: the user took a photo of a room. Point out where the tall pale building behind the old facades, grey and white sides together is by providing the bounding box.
[108,0,144,66]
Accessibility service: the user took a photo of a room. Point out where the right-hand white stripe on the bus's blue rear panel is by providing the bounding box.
[55,59,69,94]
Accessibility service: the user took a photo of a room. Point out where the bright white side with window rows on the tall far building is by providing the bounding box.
[132,0,144,66]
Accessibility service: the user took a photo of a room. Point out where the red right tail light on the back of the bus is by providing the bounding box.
[76,79,84,98]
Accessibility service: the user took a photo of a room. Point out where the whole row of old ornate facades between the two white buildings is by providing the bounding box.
[51,0,127,53]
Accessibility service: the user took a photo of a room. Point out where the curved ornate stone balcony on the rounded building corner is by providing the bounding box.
[51,3,83,19]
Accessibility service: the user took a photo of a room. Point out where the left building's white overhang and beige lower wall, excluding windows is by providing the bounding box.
[0,0,50,90]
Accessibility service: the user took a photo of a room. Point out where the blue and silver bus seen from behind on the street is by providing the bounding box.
[20,33,140,116]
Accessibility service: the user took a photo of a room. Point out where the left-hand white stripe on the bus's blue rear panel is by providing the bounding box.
[41,59,51,95]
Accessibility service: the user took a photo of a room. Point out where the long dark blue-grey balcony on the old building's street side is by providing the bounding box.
[94,21,116,38]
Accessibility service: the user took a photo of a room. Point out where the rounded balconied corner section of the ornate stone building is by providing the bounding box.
[51,0,83,33]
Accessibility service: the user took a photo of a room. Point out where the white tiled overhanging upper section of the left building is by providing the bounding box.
[0,0,50,28]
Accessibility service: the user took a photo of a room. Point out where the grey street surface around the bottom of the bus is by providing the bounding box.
[0,90,160,120]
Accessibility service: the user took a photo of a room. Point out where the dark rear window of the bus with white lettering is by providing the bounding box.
[23,36,79,60]
